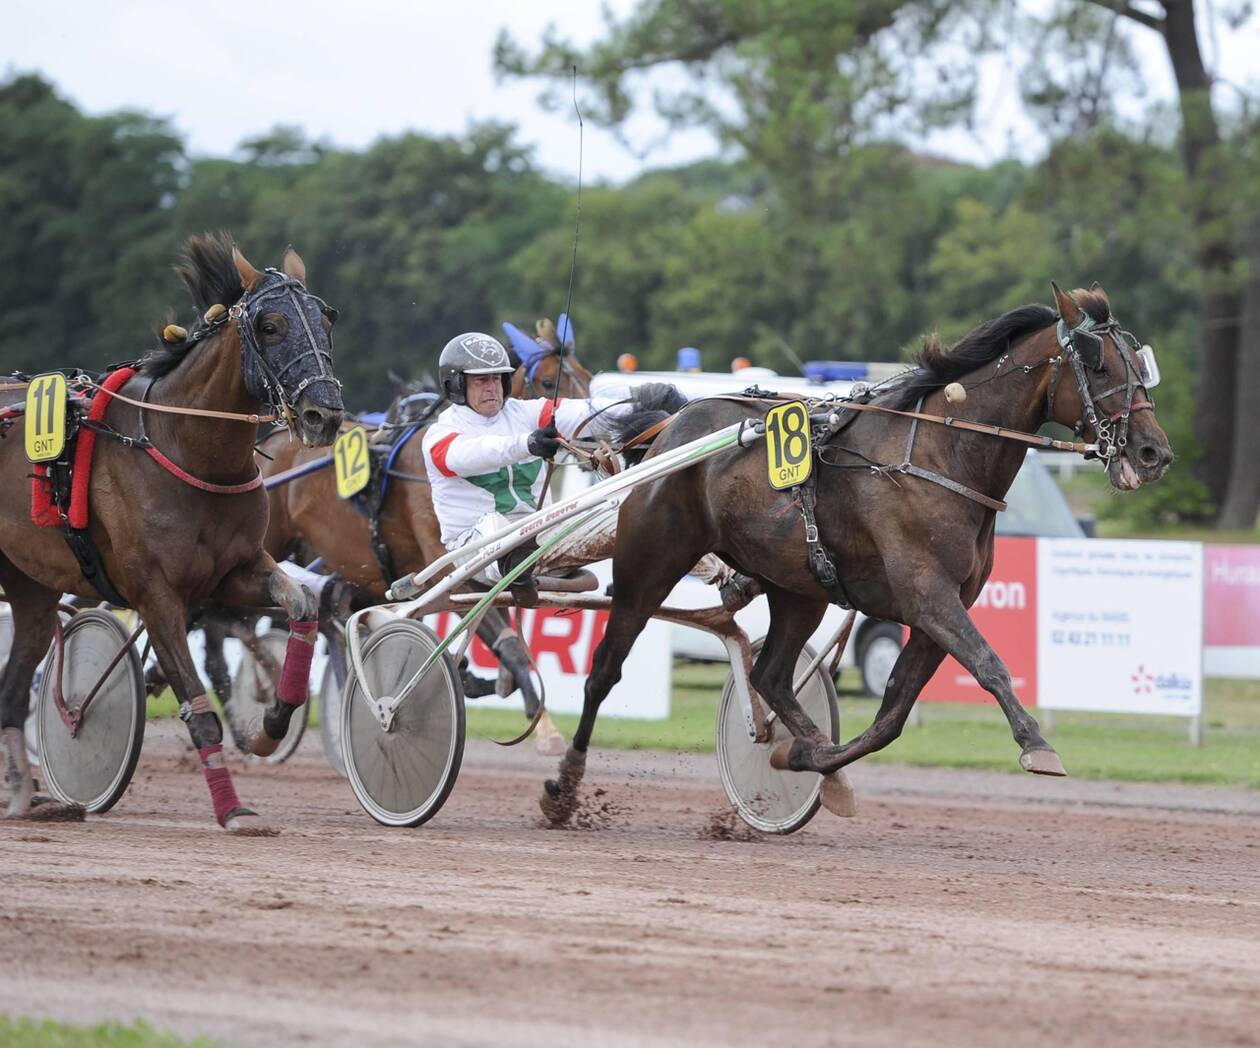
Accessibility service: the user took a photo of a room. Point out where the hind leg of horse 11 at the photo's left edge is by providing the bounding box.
[0,557,60,819]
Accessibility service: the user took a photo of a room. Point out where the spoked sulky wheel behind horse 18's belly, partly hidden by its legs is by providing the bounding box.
[717,640,840,834]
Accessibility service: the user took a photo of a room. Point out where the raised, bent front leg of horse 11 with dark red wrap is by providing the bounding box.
[214,550,319,757]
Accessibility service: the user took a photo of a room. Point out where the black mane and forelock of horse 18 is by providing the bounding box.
[877,287,1111,411]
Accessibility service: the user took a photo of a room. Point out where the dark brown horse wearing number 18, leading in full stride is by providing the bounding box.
[542,285,1172,823]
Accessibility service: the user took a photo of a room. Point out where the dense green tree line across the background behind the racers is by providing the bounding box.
[0,8,1260,531]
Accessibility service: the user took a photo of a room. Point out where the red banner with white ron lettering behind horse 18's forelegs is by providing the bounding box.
[920,538,1037,705]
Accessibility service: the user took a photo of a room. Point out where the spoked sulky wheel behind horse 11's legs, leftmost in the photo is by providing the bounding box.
[37,608,145,811]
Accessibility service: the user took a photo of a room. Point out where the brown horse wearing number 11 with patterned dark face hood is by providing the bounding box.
[0,236,343,830]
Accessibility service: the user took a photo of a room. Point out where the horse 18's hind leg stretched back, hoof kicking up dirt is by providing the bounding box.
[538,539,696,826]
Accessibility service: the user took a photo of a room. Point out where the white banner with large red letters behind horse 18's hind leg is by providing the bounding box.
[425,561,673,721]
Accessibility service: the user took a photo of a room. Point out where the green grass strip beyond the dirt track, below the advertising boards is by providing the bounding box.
[469,663,1260,789]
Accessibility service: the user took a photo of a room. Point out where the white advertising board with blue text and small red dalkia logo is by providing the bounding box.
[1037,539,1203,717]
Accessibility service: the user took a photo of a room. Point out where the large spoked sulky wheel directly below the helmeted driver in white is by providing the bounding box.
[341,618,464,826]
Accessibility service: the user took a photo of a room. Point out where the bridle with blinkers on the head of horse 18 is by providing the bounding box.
[1046,310,1155,462]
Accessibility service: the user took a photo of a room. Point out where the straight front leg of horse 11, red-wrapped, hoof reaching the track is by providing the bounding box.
[136,590,270,834]
